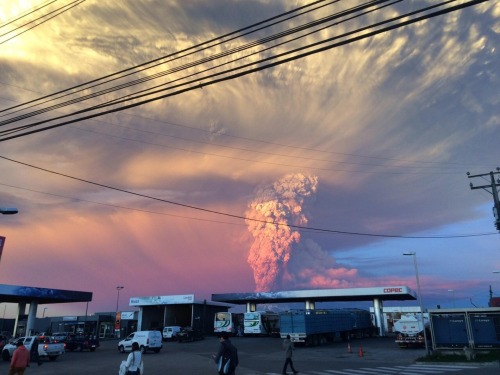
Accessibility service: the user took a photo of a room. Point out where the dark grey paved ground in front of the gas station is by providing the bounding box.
[0,337,500,375]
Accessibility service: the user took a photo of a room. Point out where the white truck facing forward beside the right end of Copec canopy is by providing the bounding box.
[394,314,431,348]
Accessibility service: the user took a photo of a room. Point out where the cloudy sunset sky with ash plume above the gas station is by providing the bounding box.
[0,0,500,317]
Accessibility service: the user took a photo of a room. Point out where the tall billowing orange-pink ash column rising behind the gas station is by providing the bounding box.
[246,173,318,292]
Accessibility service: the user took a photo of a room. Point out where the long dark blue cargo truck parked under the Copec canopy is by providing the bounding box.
[280,309,372,346]
